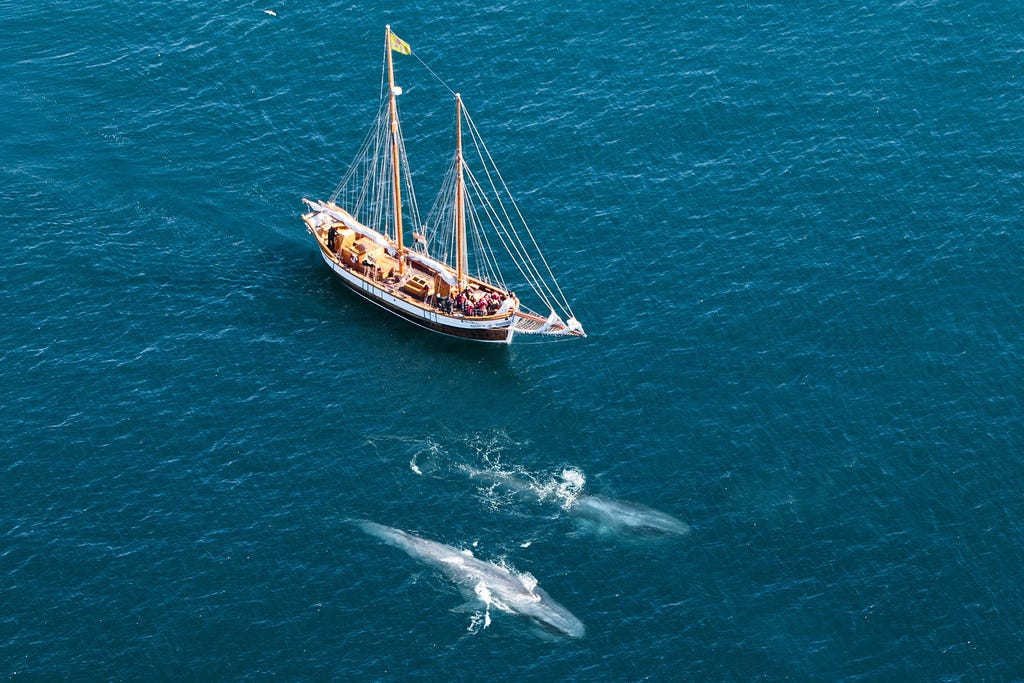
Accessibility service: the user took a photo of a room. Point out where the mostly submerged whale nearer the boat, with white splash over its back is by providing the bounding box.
[465,468,690,537]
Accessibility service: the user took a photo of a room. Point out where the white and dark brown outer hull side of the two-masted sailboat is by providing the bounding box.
[321,244,514,344]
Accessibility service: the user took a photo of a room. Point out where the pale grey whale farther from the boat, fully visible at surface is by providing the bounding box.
[354,520,586,638]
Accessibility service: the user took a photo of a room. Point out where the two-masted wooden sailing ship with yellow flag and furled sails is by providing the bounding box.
[302,27,586,343]
